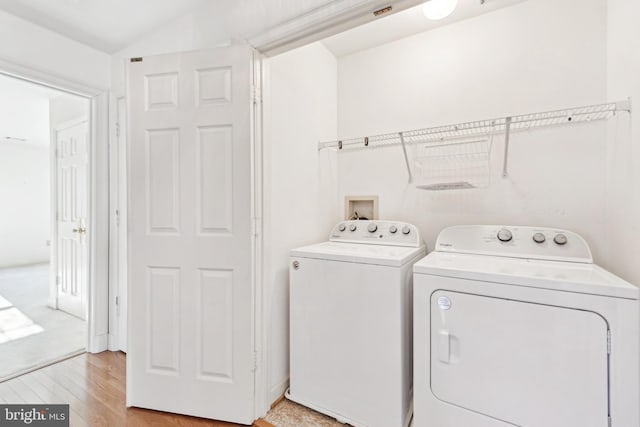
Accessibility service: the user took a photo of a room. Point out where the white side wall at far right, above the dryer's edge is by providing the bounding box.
[607,0,640,285]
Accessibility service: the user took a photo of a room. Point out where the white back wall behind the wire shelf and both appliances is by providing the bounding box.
[337,0,611,266]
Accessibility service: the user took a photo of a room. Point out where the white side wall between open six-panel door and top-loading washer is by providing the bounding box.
[264,43,337,403]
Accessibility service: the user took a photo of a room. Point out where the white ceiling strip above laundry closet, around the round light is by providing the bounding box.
[324,0,525,57]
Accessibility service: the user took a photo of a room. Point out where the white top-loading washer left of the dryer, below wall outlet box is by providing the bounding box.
[287,221,425,427]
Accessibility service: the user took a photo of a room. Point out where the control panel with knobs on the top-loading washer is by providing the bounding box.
[329,220,424,248]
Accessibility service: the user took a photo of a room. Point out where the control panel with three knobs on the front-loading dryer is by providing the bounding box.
[436,225,593,263]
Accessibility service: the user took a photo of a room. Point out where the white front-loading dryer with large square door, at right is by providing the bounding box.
[414,226,640,427]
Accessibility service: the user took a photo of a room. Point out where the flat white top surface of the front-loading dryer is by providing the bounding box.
[413,252,638,299]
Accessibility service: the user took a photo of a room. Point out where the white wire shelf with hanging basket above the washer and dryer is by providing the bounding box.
[318,99,631,190]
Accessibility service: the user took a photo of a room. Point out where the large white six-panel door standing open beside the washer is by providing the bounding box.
[127,46,255,424]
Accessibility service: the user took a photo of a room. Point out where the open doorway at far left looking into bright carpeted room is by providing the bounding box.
[0,75,91,381]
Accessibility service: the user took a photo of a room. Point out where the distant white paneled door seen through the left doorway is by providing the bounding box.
[56,120,89,319]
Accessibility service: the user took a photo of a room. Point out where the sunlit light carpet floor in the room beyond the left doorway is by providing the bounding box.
[0,264,87,380]
